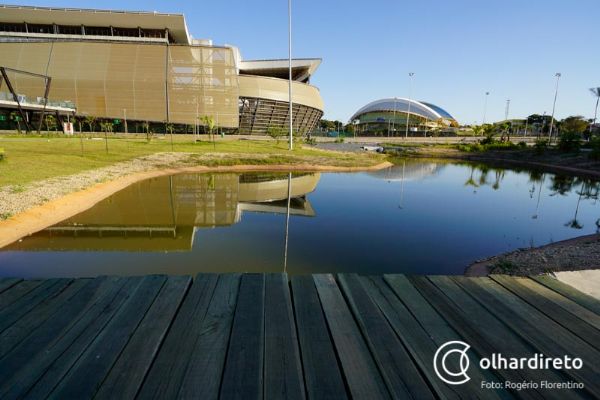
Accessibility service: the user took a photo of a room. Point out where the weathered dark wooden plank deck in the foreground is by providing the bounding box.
[0,274,600,399]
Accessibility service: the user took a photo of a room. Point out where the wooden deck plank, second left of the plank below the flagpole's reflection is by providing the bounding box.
[178,274,241,399]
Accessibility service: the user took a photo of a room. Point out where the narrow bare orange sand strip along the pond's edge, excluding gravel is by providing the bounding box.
[0,161,393,248]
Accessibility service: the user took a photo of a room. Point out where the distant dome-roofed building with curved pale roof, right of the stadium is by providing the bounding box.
[350,97,458,136]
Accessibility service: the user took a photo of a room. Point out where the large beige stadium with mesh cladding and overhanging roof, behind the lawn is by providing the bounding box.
[0,5,323,134]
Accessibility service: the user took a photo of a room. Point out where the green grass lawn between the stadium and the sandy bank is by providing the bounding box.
[0,135,383,187]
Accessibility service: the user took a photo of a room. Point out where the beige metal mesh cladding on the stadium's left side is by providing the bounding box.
[0,42,238,128]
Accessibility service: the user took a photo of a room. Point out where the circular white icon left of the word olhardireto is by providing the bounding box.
[433,340,471,385]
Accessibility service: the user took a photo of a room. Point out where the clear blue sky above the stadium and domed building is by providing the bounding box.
[11,0,600,124]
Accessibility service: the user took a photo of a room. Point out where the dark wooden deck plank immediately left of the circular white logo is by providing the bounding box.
[338,274,434,399]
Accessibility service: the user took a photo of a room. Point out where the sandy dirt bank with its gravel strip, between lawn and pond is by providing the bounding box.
[0,153,392,248]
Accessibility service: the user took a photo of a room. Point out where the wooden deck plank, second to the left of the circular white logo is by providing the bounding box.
[313,274,390,399]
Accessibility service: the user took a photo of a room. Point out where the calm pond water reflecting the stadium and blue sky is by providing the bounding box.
[0,161,600,277]
